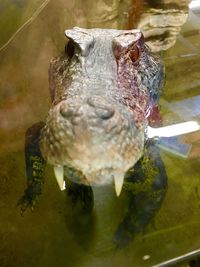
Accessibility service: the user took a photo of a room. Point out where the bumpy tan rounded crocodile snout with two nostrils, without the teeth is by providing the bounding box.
[40,95,144,188]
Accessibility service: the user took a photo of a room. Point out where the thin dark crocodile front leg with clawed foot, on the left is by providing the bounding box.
[18,122,45,214]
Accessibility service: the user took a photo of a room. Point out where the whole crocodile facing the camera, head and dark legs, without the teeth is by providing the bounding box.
[18,28,167,247]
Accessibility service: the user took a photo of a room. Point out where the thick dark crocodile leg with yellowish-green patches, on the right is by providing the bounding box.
[114,141,167,247]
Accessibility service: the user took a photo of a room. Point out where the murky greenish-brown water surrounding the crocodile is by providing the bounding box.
[0,0,200,267]
